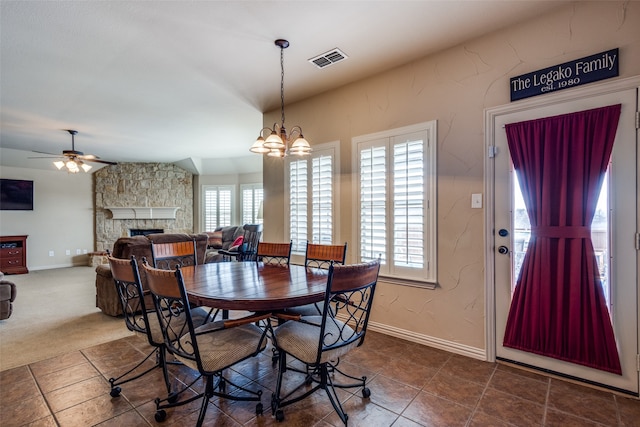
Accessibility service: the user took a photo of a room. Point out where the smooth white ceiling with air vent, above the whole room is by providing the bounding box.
[0,0,560,175]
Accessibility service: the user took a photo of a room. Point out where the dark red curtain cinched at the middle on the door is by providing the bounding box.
[504,105,621,374]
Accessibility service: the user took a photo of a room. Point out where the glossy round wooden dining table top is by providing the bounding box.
[181,262,328,312]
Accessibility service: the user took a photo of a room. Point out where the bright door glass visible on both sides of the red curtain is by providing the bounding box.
[511,171,611,312]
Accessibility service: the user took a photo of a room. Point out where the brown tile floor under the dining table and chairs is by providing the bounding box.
[0,332,640,427]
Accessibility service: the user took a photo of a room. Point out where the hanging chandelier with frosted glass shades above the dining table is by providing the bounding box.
[249,39,311,157]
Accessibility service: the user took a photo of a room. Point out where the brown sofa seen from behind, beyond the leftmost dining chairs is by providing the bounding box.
[96,233,208,316]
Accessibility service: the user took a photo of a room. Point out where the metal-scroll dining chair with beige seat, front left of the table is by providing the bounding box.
[142,261,271,426]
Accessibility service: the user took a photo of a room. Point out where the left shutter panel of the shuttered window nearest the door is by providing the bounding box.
[360,146,387,263]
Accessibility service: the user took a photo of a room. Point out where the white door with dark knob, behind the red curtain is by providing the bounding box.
[487,83,639,395]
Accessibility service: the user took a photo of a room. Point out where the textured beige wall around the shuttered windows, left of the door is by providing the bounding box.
[263,2,640,356]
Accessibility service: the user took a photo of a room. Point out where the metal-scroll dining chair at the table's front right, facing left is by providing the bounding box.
[271,260,380,425]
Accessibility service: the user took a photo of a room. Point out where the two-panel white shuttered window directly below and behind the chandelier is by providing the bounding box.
[285,143,338,253]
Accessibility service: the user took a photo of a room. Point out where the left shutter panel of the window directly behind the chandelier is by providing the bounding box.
[289,160,308,252]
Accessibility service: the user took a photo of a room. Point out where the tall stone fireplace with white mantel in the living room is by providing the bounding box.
[93,163,193,251]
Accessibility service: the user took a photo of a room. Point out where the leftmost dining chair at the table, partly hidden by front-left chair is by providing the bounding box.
[107,252,208,398]
